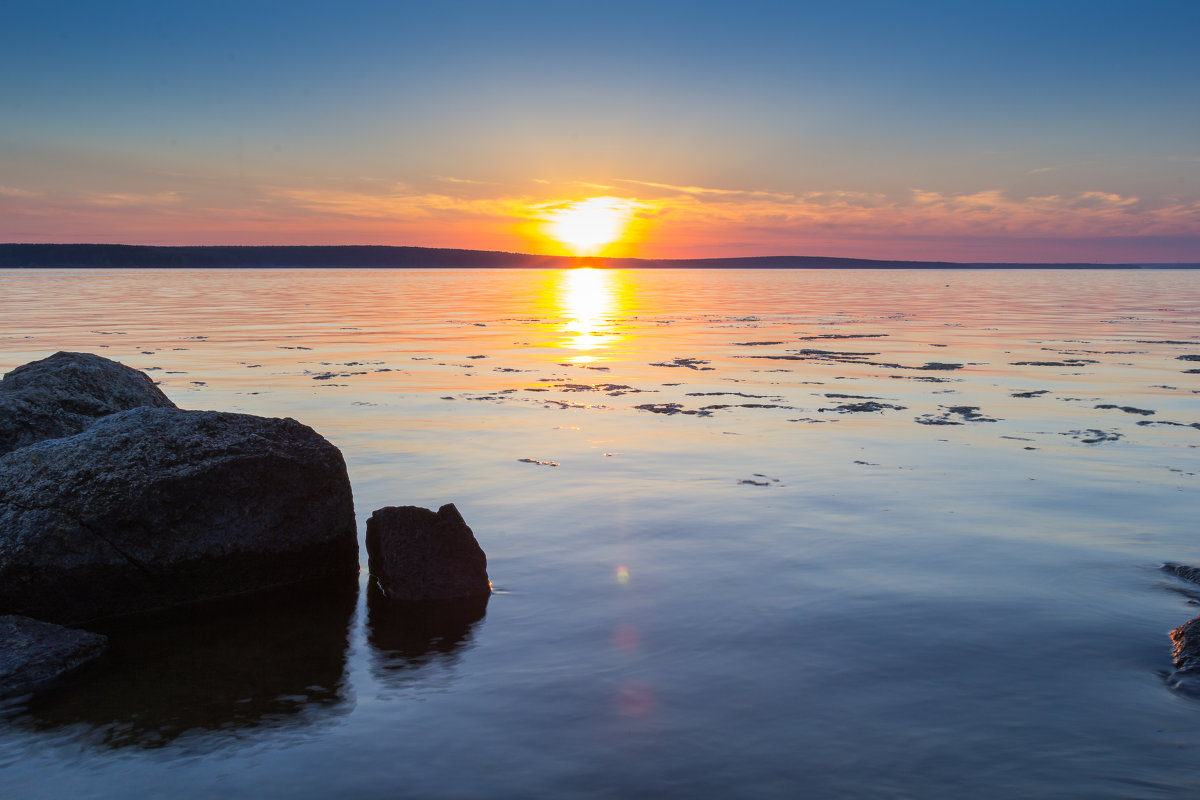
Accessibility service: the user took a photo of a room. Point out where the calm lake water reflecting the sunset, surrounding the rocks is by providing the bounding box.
[0,270,1200,798]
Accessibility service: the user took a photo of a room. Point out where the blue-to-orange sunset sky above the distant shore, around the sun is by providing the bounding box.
[0,0,1200,263]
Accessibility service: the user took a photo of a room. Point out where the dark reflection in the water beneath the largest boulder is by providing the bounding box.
[22,577,358,750]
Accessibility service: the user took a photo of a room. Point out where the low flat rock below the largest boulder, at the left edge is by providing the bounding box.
[0,615,108,698]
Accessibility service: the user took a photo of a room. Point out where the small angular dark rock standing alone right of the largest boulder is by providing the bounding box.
[367,503,492,601]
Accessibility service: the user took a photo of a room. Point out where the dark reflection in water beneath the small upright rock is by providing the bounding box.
[367,581,488,688]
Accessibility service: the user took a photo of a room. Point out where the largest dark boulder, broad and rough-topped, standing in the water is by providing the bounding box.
[0,408,358,622]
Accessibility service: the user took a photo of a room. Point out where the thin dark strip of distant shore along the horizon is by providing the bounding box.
[0,243,1200,270]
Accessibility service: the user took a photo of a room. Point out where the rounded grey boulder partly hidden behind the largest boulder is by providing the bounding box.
[0,353,175,453]
